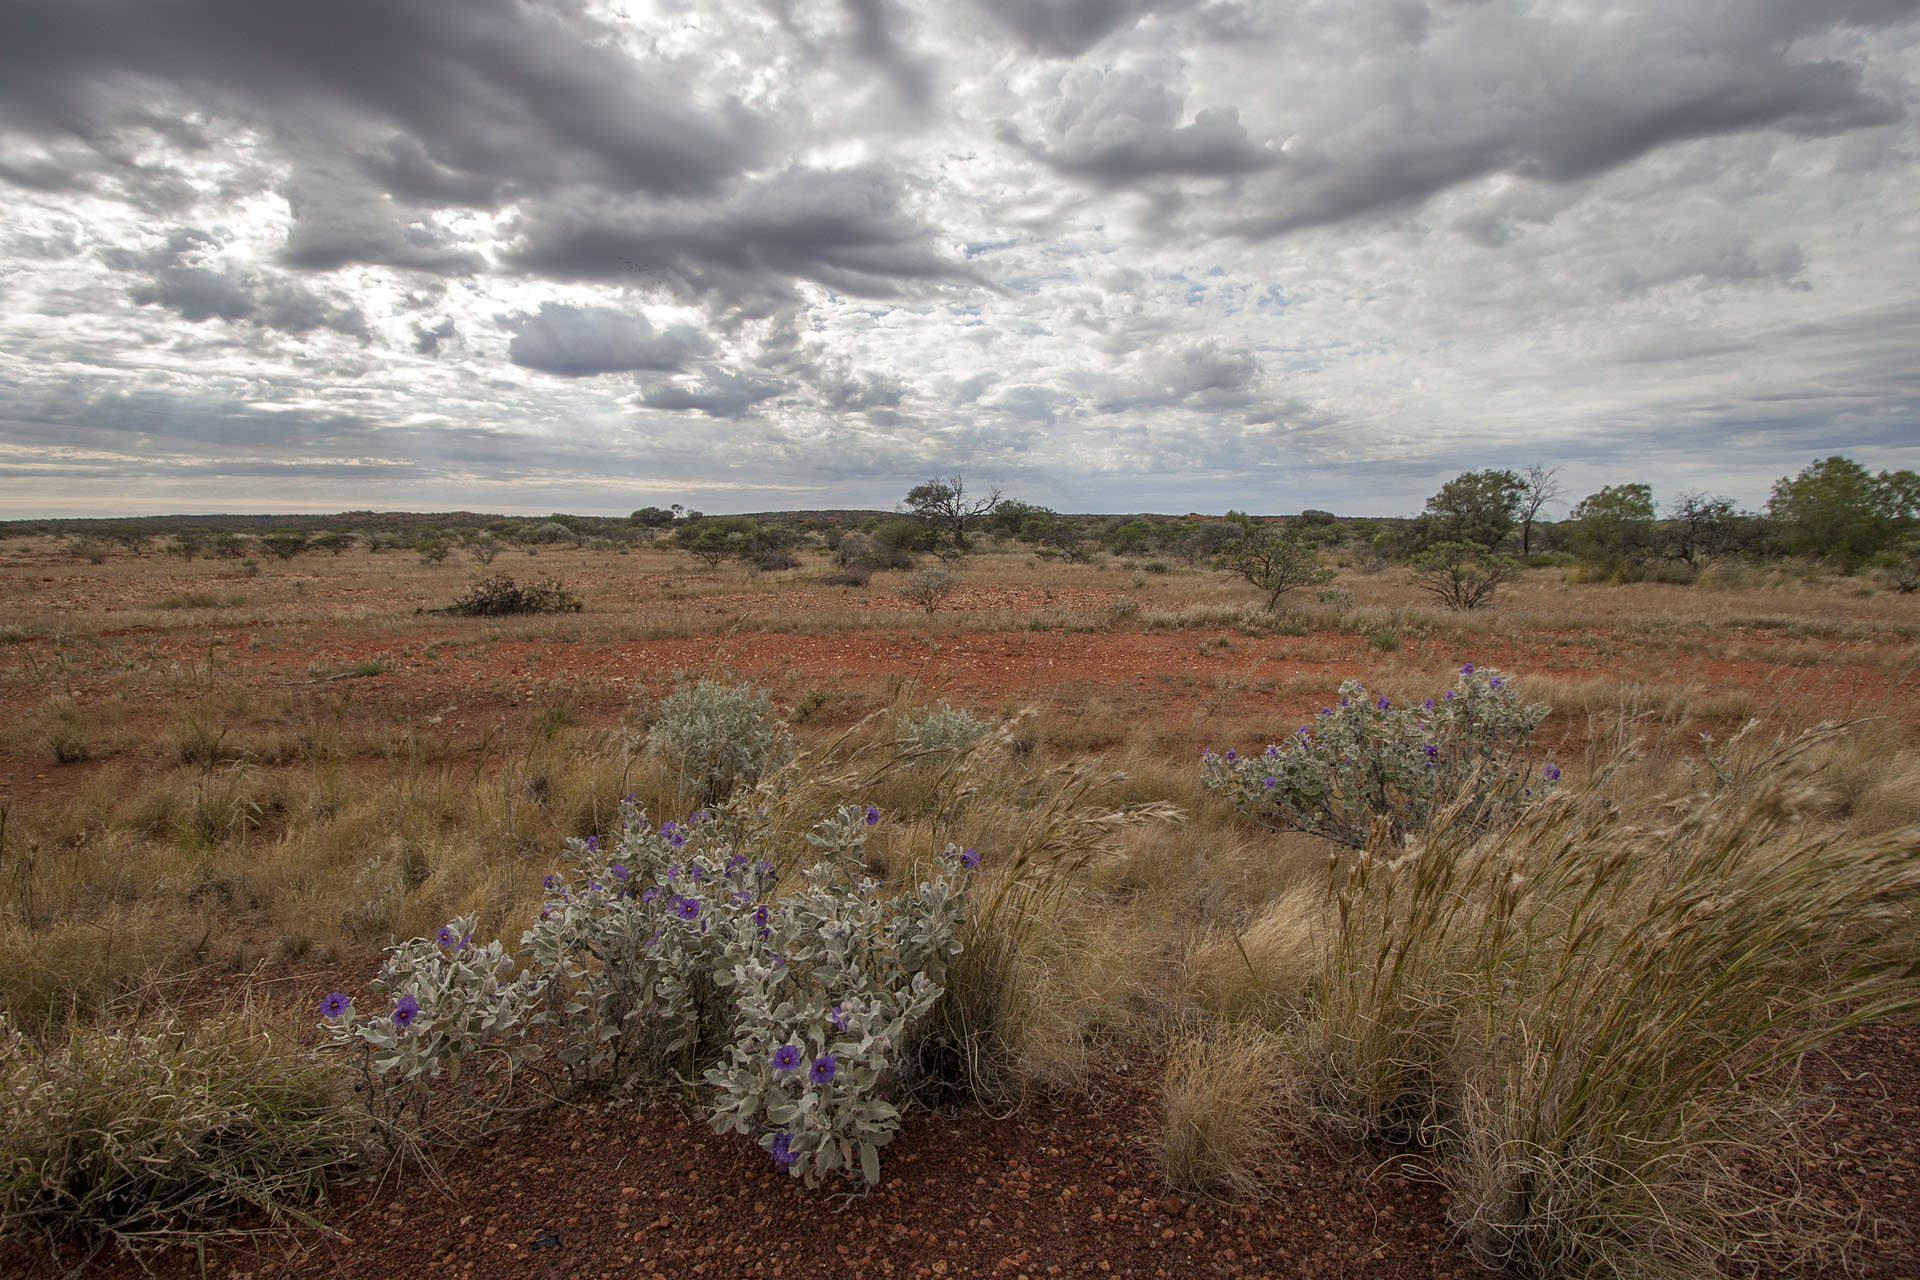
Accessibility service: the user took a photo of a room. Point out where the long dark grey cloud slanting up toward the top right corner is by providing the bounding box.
[1221,4,1914,240]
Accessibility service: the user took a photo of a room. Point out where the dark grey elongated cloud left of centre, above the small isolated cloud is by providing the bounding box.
[507,167,979,301]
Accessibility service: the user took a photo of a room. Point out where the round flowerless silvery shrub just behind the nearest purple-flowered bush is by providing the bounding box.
[647,676,793,804]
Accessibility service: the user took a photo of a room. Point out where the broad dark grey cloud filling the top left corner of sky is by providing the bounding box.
[0,0,753,198]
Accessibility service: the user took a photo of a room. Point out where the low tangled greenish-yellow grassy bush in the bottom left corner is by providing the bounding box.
[0,1013,363,1245]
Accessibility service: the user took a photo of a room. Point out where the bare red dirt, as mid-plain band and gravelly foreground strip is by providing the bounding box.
[0,553,1920,1280]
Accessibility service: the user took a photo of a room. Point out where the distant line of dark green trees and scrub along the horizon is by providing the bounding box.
[11,455,1920,608]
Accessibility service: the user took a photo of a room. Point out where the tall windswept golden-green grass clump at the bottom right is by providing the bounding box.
[1283,731,1920,1276]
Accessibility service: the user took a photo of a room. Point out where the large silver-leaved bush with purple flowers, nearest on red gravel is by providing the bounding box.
[321,798,979,1186]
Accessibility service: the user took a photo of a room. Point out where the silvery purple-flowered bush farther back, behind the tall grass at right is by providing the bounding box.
[1202,662,1559,848]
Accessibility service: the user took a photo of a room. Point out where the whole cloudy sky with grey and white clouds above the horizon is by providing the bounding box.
[0,0,1920,518]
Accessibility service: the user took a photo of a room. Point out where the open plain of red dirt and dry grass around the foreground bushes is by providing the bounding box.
[0,539,1920,1280]
